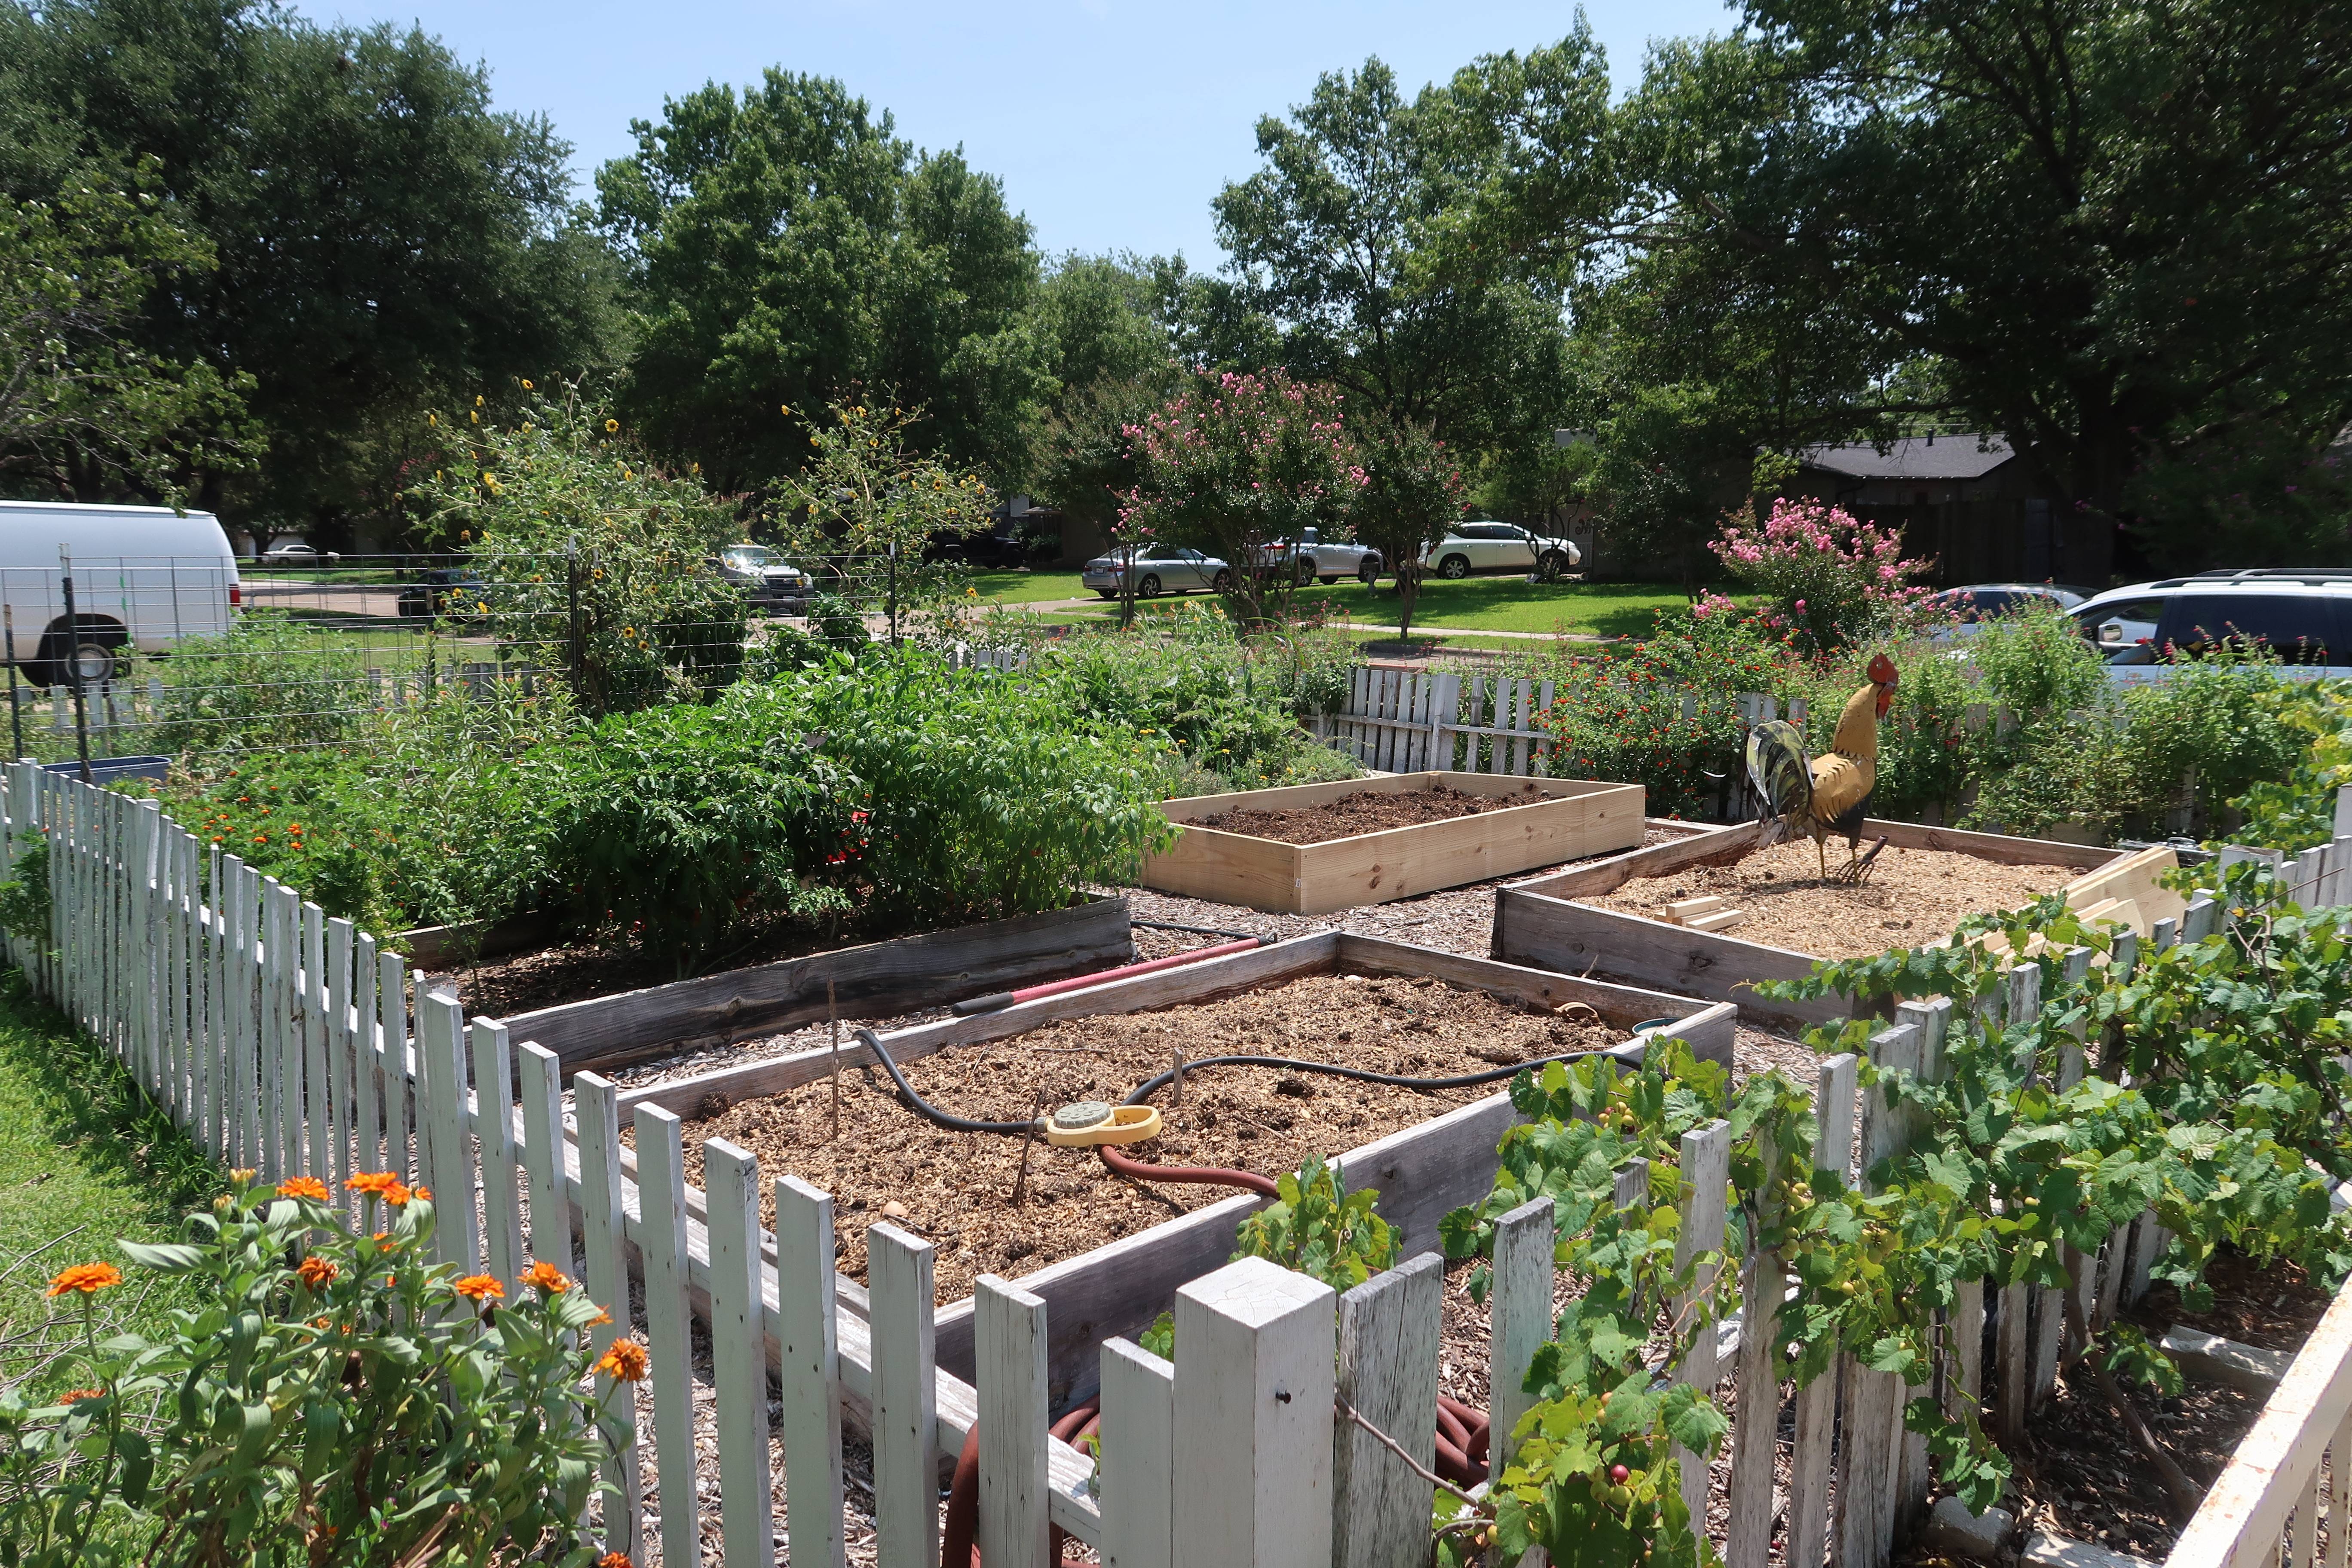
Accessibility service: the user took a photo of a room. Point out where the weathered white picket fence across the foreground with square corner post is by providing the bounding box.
[0,764,2352,1568]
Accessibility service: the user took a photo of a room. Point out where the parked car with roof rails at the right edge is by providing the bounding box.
[2072,569,2352,686]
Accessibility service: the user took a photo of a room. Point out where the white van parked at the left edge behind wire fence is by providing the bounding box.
[0,501,242,686]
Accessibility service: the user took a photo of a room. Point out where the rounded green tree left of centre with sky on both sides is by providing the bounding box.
[597,68,1051,489]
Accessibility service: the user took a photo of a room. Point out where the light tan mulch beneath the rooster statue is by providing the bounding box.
[1576,839,2077,959]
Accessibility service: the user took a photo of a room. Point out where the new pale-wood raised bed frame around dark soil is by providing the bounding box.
[1141,773,1642,915]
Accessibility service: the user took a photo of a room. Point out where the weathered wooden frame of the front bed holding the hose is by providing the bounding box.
[619,931,1736,1408]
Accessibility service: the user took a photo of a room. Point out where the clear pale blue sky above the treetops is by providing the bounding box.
[301,0,1733,266]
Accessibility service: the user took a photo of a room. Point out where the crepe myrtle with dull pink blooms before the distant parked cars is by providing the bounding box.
[1120,371,1364,625]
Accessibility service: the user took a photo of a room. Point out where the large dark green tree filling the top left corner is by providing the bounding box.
[0,0,619,541]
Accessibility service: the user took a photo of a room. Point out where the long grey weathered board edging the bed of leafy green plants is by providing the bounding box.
[484,898,1134,1072]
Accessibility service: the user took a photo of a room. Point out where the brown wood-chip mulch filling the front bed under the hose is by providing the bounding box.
[644,976,1623,1302]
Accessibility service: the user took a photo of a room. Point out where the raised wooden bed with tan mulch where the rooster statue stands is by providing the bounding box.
[1494,821,2176,1032]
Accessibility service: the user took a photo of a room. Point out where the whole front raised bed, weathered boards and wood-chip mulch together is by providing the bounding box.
[602,933,1733,1403]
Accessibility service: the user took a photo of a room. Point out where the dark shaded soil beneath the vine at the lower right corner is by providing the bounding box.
[1910,1253,2328,1563]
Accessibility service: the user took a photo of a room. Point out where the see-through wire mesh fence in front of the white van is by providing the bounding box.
[0,545,965,776]
